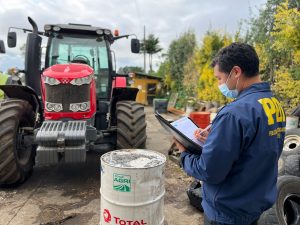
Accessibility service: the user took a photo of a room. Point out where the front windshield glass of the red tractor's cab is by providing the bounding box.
[46,35,109,98]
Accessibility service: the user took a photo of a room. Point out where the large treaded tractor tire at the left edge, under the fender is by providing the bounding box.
[0,99,35,187]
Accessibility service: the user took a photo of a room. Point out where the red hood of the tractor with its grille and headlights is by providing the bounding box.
[41,63,96,120]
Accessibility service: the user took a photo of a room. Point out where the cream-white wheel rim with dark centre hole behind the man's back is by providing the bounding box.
[282,128,300,156]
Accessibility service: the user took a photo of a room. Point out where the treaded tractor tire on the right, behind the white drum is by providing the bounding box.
[116,101,147,149]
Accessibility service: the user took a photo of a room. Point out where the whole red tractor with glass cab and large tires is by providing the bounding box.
[0,18,146,186]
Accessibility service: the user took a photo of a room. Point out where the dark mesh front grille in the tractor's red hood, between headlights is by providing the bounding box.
[45,83,90,112]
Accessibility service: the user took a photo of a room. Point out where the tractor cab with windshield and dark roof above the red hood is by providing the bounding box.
[44,24,113,99]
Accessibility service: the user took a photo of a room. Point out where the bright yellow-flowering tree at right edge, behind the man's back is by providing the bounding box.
[271,0,300,110]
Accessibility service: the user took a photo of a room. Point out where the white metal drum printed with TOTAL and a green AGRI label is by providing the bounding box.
[100,149,166,225]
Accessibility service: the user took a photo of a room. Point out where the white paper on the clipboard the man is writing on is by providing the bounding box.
[171,116,203,147]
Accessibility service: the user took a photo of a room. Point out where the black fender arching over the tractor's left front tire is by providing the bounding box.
[0,85,44,121]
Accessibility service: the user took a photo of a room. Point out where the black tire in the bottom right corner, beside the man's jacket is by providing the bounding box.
[258,176,300,225]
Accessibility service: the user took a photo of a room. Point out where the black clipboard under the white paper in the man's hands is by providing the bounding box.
[155,112,202,155]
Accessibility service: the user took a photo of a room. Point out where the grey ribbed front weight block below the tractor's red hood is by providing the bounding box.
[36,121,87,165]
